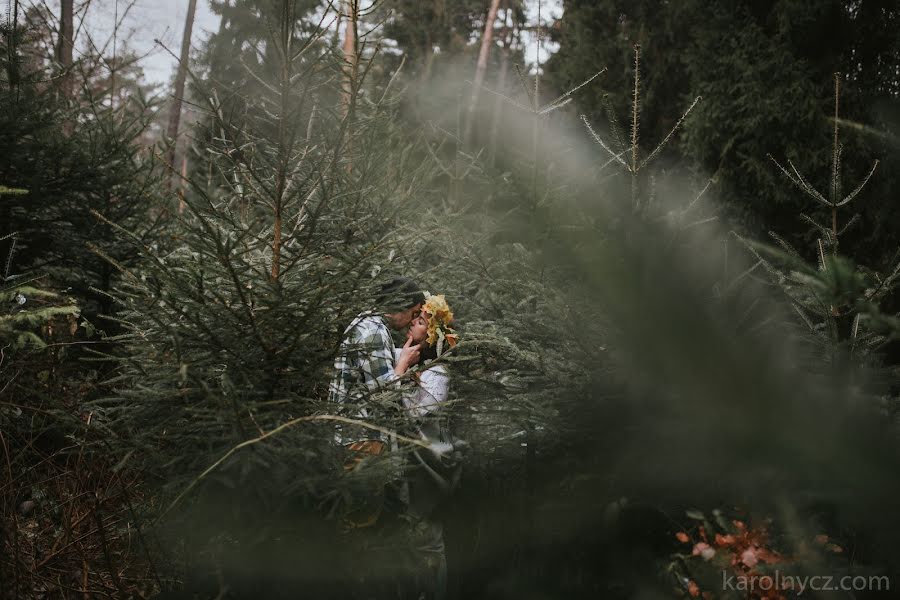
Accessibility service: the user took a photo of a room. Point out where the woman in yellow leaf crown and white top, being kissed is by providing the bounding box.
[397,292,462,600]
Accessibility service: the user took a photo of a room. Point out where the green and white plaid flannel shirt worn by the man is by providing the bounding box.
[328,312,398,444]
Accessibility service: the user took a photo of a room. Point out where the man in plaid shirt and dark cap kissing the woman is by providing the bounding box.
[329,277,425,446]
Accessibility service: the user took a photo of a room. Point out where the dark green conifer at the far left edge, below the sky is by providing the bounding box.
[0,21,165,320]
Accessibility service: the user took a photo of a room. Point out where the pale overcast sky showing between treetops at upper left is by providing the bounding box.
[21,0,562,84]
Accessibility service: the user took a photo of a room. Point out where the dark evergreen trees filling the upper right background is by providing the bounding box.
[547,0,900,266]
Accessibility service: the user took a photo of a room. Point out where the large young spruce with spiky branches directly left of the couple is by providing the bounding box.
[91,5,440,580]
